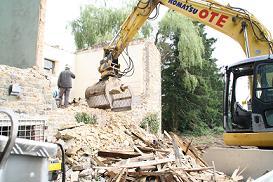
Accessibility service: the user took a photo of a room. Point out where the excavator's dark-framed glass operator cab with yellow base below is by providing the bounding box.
[224,56,273,147]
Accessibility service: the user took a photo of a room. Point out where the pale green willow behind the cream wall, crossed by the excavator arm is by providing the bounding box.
[70,1,152,49]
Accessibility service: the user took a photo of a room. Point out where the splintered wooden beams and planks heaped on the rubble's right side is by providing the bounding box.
[94,130,243,182]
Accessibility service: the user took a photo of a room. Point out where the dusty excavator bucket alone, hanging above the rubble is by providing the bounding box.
[85,77,132,111]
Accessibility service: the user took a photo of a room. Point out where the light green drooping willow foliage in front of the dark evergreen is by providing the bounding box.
[159,11,204,69]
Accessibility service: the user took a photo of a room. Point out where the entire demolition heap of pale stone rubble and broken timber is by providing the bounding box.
[56,113,242,182]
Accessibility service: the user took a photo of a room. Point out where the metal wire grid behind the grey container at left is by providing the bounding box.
[0,119,47,141]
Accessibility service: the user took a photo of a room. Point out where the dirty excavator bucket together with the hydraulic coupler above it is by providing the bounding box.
[85,49,132,111]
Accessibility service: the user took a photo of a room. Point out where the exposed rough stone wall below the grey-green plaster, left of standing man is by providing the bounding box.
[0,65,56,115]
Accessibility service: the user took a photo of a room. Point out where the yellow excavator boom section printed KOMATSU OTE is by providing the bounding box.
[160,0,272,57]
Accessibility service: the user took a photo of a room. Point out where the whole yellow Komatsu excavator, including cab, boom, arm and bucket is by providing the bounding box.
[85,0,273,147]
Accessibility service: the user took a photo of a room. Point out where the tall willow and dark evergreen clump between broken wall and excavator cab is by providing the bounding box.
[157,11,222,133]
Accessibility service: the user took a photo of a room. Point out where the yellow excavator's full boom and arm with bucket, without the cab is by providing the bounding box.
[86,0,272,110]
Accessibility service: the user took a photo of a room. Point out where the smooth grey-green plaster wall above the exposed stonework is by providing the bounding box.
[0,0,40,68]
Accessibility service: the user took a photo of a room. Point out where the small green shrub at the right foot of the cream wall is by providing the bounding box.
[140,113,159,134]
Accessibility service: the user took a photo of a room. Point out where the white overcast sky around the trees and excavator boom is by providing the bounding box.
[45,0,273,66]
